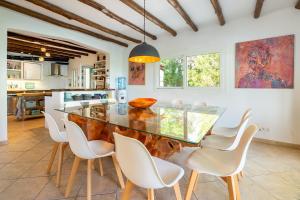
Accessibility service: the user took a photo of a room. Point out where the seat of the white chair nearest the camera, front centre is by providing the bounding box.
[152,157,184,187]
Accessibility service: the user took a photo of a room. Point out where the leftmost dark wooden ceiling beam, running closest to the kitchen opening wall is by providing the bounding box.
[0,0,128,47]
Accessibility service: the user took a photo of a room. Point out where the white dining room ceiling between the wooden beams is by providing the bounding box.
[7,0,297,44]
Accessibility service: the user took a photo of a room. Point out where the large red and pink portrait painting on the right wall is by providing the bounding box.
[235,35,295,88]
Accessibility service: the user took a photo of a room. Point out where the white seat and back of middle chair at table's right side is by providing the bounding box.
[201,116,250,151]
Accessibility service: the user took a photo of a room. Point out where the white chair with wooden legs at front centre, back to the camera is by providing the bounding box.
[114,133,184,200]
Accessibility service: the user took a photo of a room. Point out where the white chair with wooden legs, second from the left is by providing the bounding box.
[64,120,125,200]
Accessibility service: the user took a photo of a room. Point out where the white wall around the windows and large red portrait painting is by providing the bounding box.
[126,8,300,144]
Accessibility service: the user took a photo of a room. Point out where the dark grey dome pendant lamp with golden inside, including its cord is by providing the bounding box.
[128,0,160,63]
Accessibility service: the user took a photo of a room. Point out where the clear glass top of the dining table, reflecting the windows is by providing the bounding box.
[56,104,225,144]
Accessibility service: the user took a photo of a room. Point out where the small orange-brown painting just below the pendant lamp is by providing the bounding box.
[128,62,145,85]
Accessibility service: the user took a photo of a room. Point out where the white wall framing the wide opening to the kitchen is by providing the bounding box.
[0,7,126,142]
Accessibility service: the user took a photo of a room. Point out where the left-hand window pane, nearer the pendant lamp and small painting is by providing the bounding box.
[159,57,184,87]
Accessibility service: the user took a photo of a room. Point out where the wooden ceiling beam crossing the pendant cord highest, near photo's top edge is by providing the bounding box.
[120,0,177,37]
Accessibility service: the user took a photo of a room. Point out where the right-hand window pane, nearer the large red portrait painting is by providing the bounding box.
[187,53,221,87]
